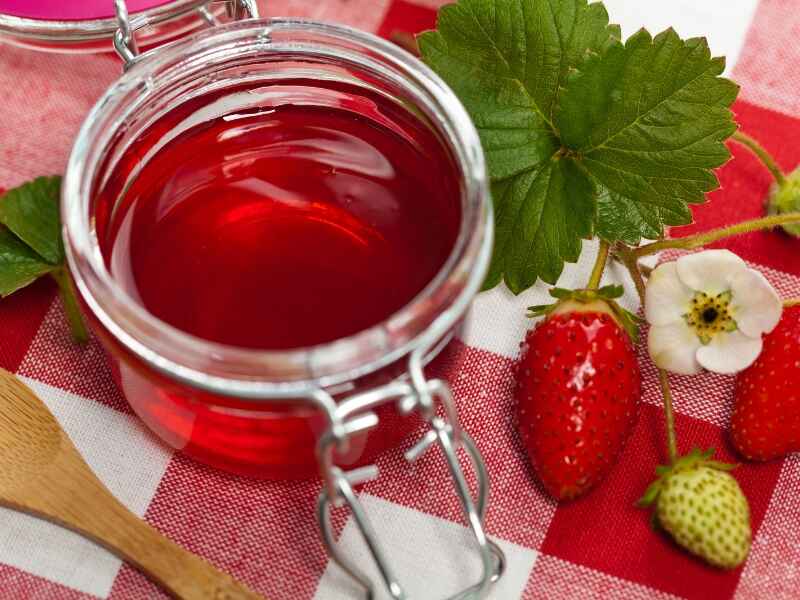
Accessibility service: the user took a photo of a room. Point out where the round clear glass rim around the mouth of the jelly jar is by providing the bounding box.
[61,18,493,399]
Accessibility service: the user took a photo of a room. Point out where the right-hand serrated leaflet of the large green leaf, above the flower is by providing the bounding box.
[556,29,738,244]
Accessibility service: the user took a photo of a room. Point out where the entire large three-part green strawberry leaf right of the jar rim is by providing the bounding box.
[419,0,738,293]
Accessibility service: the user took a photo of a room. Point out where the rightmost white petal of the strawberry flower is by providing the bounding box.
[731,269,783,337]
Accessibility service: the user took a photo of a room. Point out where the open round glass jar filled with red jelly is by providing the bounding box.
[62,20,492,478]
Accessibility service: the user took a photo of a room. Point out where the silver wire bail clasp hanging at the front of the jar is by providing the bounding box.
[317,349,505,600]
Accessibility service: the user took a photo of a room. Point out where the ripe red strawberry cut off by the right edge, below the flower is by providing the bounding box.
[731,306,800,460]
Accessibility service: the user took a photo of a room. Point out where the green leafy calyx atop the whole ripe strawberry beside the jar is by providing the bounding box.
[528,285,642,344]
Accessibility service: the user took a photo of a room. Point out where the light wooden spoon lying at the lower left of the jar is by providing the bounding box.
[0,369,262,600]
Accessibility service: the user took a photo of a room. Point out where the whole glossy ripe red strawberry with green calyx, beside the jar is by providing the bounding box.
[516,290,641,500]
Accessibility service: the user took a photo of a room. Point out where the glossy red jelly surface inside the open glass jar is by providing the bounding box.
[98,84,460,349]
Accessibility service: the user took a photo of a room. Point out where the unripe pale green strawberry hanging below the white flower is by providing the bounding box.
[640,450,752,569]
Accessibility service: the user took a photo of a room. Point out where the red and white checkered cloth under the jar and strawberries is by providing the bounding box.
[0,0,800,600]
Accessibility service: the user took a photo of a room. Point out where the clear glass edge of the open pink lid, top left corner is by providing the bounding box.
[0,0,208,44]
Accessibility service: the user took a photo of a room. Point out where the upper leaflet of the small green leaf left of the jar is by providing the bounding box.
[0,177,64,265]
